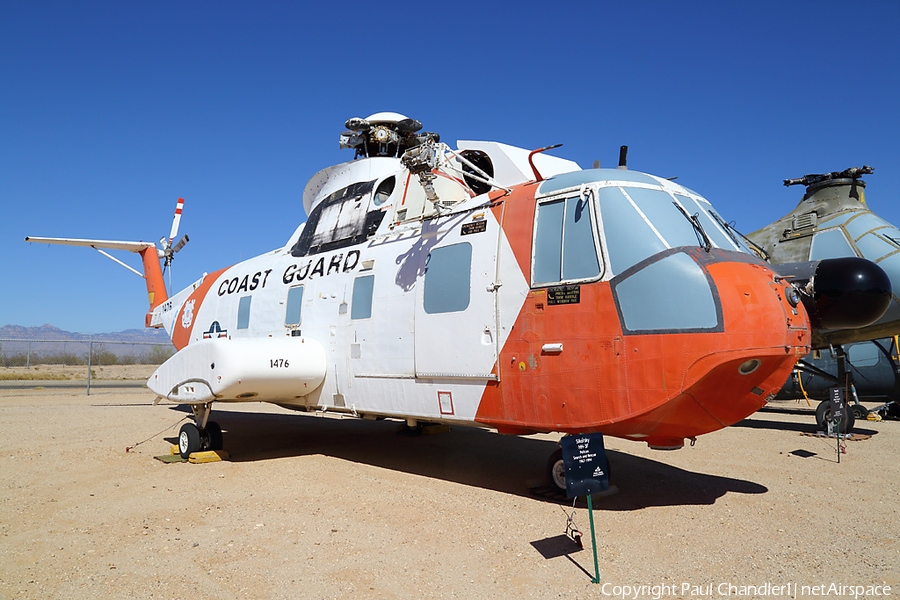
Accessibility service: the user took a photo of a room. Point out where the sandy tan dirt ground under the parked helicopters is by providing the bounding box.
[0,389,900,599]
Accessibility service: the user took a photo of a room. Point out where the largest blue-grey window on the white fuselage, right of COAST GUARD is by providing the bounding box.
[423,242,472,314]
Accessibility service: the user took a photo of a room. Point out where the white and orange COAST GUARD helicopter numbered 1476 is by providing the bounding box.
[26,113,891,490]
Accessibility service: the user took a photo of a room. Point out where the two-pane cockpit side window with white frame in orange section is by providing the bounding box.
[532,196,600,285]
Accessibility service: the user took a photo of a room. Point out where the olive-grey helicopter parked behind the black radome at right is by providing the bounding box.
[748,165,900,432]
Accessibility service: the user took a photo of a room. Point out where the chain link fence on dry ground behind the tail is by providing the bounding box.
[0,339,175,395]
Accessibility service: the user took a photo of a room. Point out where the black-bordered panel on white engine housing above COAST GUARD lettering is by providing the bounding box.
[291,180,389,257]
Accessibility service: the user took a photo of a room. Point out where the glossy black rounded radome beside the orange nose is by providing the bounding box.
[804,257,891,329]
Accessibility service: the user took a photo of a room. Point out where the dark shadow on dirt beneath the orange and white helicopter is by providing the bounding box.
[170,411,768,511]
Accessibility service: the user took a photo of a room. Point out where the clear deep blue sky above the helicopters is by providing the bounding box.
[0,0,900,333]
